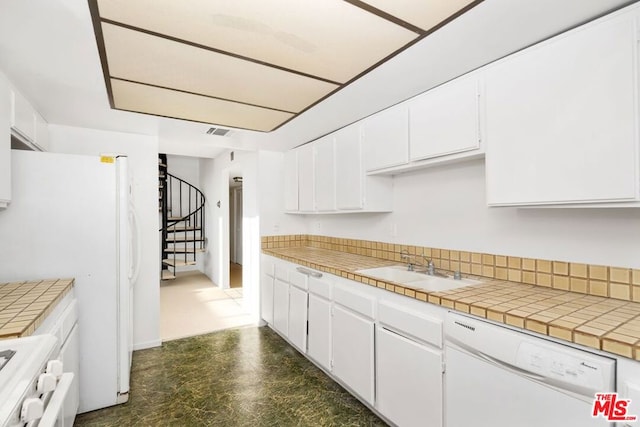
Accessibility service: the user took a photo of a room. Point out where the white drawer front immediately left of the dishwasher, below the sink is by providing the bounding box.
[378,302,442,348]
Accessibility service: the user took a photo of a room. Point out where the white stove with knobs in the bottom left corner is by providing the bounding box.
[0,334,73,427]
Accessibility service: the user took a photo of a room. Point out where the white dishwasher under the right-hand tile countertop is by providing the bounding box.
[445,312,616,427]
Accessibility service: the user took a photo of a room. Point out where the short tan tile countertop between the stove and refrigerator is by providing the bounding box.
[0,279,74,339]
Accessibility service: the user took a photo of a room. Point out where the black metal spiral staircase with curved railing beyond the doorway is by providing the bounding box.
[158,154,207,280]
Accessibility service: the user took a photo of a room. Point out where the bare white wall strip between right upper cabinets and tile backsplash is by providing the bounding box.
[300,160,640,268]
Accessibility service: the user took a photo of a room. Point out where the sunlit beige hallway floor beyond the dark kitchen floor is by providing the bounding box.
[160,271,254,341]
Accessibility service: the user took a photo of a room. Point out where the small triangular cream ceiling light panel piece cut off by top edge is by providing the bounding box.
[362,0,479,31]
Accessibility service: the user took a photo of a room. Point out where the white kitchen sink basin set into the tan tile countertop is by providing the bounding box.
[356,265,482,292]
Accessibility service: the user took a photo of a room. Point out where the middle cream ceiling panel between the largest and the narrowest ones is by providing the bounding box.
[102,23,338,113]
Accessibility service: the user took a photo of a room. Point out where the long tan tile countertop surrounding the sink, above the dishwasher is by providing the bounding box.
[262,247,640,360]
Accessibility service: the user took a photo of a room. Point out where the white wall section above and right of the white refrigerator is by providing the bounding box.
[49,125,161,349]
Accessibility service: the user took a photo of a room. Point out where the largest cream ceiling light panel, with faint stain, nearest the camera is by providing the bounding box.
[92,0,418,83]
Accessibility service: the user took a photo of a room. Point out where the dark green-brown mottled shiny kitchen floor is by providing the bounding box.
[75,327,386,426]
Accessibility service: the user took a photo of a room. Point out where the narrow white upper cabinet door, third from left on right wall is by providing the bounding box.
[313,135,336,212]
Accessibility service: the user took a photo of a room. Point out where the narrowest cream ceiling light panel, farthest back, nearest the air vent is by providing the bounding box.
[110,79,293,132]
